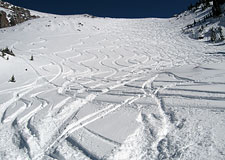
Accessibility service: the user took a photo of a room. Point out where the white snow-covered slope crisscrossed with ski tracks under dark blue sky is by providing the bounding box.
[0,6,225,160]
